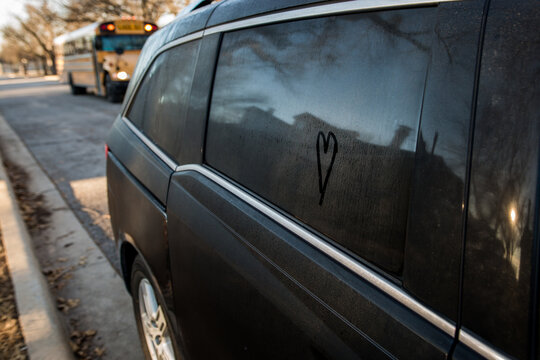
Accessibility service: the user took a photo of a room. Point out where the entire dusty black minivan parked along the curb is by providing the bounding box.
[107,0,540,359]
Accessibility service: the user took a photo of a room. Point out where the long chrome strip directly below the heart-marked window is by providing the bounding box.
[175,164,456,337]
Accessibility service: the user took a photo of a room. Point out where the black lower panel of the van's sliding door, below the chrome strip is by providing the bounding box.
[167,172,453,359]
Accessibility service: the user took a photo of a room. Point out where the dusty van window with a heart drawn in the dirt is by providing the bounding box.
[205,8,434,275]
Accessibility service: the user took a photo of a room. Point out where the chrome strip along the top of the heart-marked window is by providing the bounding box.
[204,0,462,36]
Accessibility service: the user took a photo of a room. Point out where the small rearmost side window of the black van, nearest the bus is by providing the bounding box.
[127,41,199,158]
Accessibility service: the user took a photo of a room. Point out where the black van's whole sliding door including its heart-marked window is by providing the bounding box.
[167,1,483,359]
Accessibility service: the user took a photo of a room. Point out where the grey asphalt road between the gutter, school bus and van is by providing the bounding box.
[0,78,121,271]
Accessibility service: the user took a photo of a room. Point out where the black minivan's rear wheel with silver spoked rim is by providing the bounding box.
[131,255,182,360]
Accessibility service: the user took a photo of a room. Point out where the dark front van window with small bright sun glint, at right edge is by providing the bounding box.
[462,0,540,359]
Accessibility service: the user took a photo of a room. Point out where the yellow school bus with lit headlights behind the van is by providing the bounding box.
[54,19,157,102]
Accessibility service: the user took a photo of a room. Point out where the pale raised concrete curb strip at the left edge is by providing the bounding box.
[0,131,73,360]
